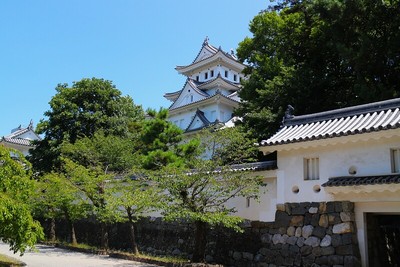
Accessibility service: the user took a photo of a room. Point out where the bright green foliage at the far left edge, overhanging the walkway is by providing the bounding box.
[0,146,43,254]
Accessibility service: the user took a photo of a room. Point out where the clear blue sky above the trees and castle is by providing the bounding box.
[0,0,269,136]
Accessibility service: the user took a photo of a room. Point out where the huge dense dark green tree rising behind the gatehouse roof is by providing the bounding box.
[237,0,400,139]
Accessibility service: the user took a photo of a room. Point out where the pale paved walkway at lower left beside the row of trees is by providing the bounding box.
[0,242,161,267]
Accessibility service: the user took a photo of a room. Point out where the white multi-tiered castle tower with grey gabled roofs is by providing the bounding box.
[164,38,245,133]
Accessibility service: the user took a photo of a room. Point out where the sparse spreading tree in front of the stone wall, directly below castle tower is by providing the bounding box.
[156,128,262,262]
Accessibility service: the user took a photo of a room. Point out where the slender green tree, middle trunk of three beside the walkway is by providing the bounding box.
[61,131,141,249]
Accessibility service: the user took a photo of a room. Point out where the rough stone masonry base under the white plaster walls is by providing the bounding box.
[138,202,360,267]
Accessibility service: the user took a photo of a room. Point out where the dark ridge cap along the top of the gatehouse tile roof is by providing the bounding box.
[285,98,400,125]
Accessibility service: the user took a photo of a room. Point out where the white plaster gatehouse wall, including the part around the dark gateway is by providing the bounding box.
[276,136,400,266]
